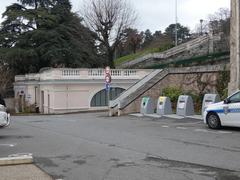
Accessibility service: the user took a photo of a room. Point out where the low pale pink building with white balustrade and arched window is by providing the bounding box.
[14,68,152,114]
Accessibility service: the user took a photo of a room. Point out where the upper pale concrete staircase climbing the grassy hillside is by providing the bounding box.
[119,35,210,68]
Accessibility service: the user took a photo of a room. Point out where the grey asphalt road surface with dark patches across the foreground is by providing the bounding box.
[0,113,240,180]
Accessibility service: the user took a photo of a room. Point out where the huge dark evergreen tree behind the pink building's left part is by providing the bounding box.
[0,0,103,73]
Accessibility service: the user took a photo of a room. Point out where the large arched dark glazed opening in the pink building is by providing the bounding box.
[91,87,125,107]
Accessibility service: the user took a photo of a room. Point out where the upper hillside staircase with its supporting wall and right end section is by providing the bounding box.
[119,34,229,68]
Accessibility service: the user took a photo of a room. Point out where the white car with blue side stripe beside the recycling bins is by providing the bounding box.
[203,91,240,129]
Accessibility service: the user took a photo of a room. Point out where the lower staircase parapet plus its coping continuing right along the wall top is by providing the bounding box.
[109,64,229,116]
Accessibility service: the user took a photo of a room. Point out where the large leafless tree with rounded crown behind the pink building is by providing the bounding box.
[82,0,136,68]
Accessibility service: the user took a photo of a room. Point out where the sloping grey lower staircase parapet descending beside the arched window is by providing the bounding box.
[109,69,168,116]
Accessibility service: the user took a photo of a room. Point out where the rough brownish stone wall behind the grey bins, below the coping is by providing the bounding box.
[118,72,218,115]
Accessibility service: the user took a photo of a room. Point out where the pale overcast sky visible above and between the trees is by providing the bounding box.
[0,0,230,32]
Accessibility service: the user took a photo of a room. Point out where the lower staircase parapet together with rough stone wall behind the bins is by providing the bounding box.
[109,64,226,116]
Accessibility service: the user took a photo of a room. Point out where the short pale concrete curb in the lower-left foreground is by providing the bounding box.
[0,155,33,166]
